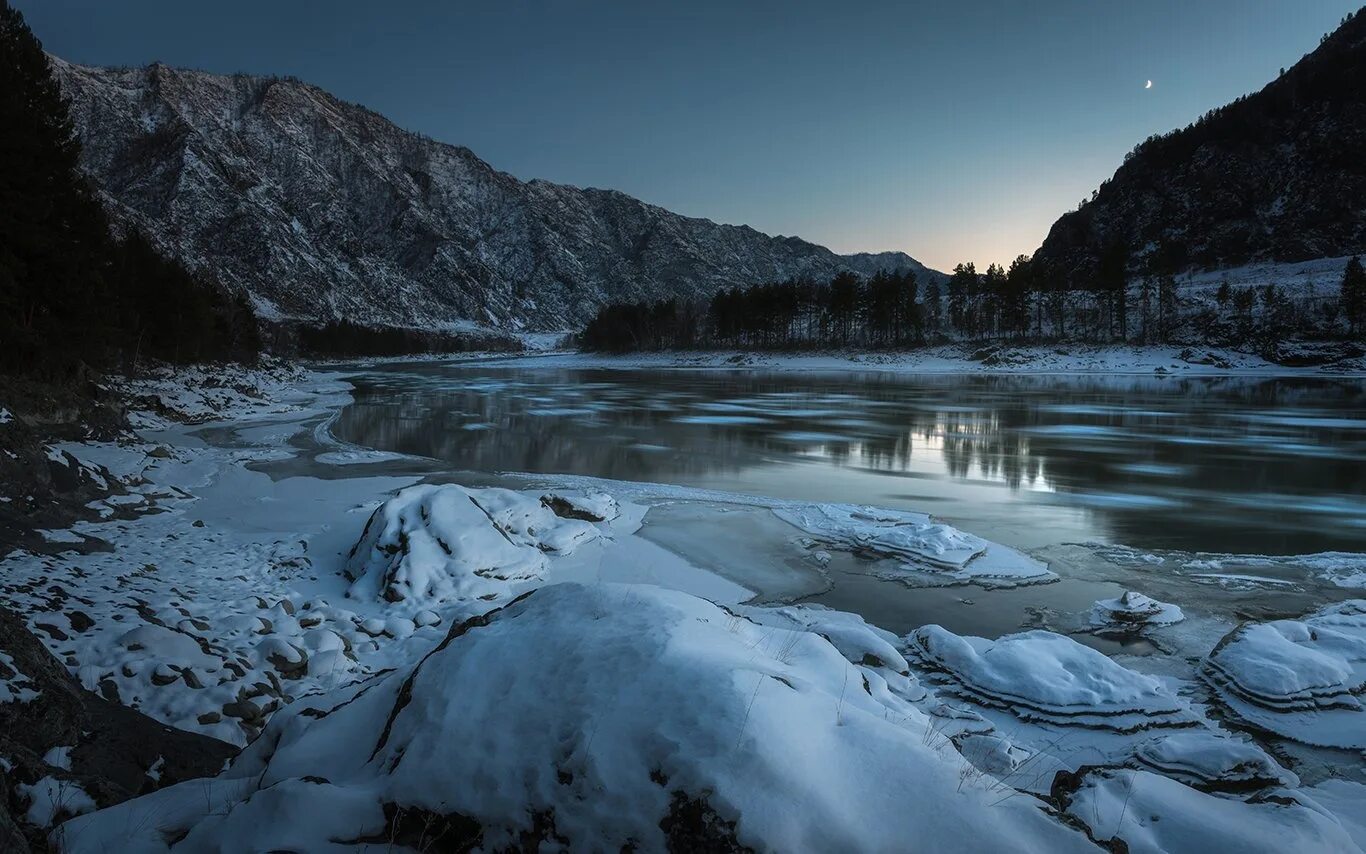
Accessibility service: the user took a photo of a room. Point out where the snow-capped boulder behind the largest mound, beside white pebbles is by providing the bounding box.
[346,484,600,603]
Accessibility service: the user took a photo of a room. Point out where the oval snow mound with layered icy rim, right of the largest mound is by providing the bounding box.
[906,626,1194,732]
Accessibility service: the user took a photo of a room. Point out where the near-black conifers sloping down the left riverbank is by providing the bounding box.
[0,0,261,380]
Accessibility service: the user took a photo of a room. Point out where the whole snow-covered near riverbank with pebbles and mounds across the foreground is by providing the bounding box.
[0,357,1366,851]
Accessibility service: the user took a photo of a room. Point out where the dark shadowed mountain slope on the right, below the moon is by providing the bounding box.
[1034,12,1366,287]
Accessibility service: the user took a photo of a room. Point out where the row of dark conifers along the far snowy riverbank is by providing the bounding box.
[579,247,1366,353]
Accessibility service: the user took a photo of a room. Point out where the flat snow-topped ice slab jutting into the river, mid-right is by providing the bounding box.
[773,504,1057,586]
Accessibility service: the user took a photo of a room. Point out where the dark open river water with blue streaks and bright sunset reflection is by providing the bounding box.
[333,365,1366,553]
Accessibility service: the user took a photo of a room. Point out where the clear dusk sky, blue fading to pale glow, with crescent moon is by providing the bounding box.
[15,0,1355,269]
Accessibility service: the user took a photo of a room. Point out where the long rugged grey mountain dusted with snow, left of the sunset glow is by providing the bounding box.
[52,57,938,329]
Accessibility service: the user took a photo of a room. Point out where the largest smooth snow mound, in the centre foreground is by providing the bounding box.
[60,583,1094,853]
